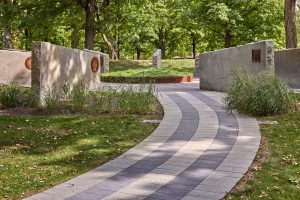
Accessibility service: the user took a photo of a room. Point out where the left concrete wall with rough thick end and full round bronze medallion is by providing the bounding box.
[31,42,101,103]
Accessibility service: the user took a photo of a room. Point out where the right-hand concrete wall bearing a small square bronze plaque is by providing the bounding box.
[196,40,274,92]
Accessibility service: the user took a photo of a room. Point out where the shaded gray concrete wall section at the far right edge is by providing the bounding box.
[275,49,300,88]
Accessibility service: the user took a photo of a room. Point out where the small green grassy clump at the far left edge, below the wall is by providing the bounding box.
[0,83,21,108]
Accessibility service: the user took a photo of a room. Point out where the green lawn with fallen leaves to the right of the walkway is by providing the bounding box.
[225,95,300,200]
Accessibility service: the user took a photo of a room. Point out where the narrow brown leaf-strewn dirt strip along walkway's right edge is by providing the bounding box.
[224,137,271,199]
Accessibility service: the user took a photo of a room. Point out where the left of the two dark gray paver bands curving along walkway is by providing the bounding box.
[68,94,200,200]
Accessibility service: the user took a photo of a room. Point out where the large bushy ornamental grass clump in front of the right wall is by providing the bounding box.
[224,72,295,116]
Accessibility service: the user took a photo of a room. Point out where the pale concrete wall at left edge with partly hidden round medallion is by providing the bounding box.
[0,50,31,86]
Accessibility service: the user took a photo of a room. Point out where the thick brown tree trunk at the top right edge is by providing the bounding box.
[284,0,298,49]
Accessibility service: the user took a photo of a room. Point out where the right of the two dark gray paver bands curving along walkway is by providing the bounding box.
[145,93,238,200]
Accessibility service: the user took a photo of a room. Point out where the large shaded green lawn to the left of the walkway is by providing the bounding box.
[0,115,162,199]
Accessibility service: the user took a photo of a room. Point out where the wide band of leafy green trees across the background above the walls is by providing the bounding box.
[0,0,300,59]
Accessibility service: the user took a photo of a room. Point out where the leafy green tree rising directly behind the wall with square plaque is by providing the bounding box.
[194,0,281,48]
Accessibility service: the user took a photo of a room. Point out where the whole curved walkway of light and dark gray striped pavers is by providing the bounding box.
[25,84,260,200]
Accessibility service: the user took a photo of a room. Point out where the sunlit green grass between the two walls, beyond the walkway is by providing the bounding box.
[101,59,195,82]
